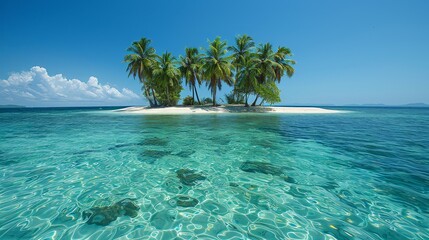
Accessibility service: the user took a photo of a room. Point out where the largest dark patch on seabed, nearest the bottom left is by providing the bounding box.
[82,198,140,226]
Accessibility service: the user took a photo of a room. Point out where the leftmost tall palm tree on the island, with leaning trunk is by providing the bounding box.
[124,38,157,107]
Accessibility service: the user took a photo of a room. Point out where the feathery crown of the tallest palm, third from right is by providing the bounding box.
[228,34,255,74]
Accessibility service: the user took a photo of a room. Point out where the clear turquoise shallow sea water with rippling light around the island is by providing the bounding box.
[0,108,429,239]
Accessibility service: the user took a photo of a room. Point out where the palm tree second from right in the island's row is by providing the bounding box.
[252,43,280,106]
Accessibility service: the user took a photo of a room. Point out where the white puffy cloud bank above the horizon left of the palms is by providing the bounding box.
[0,66,142,106]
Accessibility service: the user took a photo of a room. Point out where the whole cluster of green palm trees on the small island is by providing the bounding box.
[125,35,295,106]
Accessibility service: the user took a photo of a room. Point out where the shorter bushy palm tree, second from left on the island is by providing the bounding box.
[153,52,180,106]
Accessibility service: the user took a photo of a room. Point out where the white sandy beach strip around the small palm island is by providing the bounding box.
[114,106,341,115]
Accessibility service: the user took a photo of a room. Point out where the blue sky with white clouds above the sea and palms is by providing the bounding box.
[0,0,429,106]
